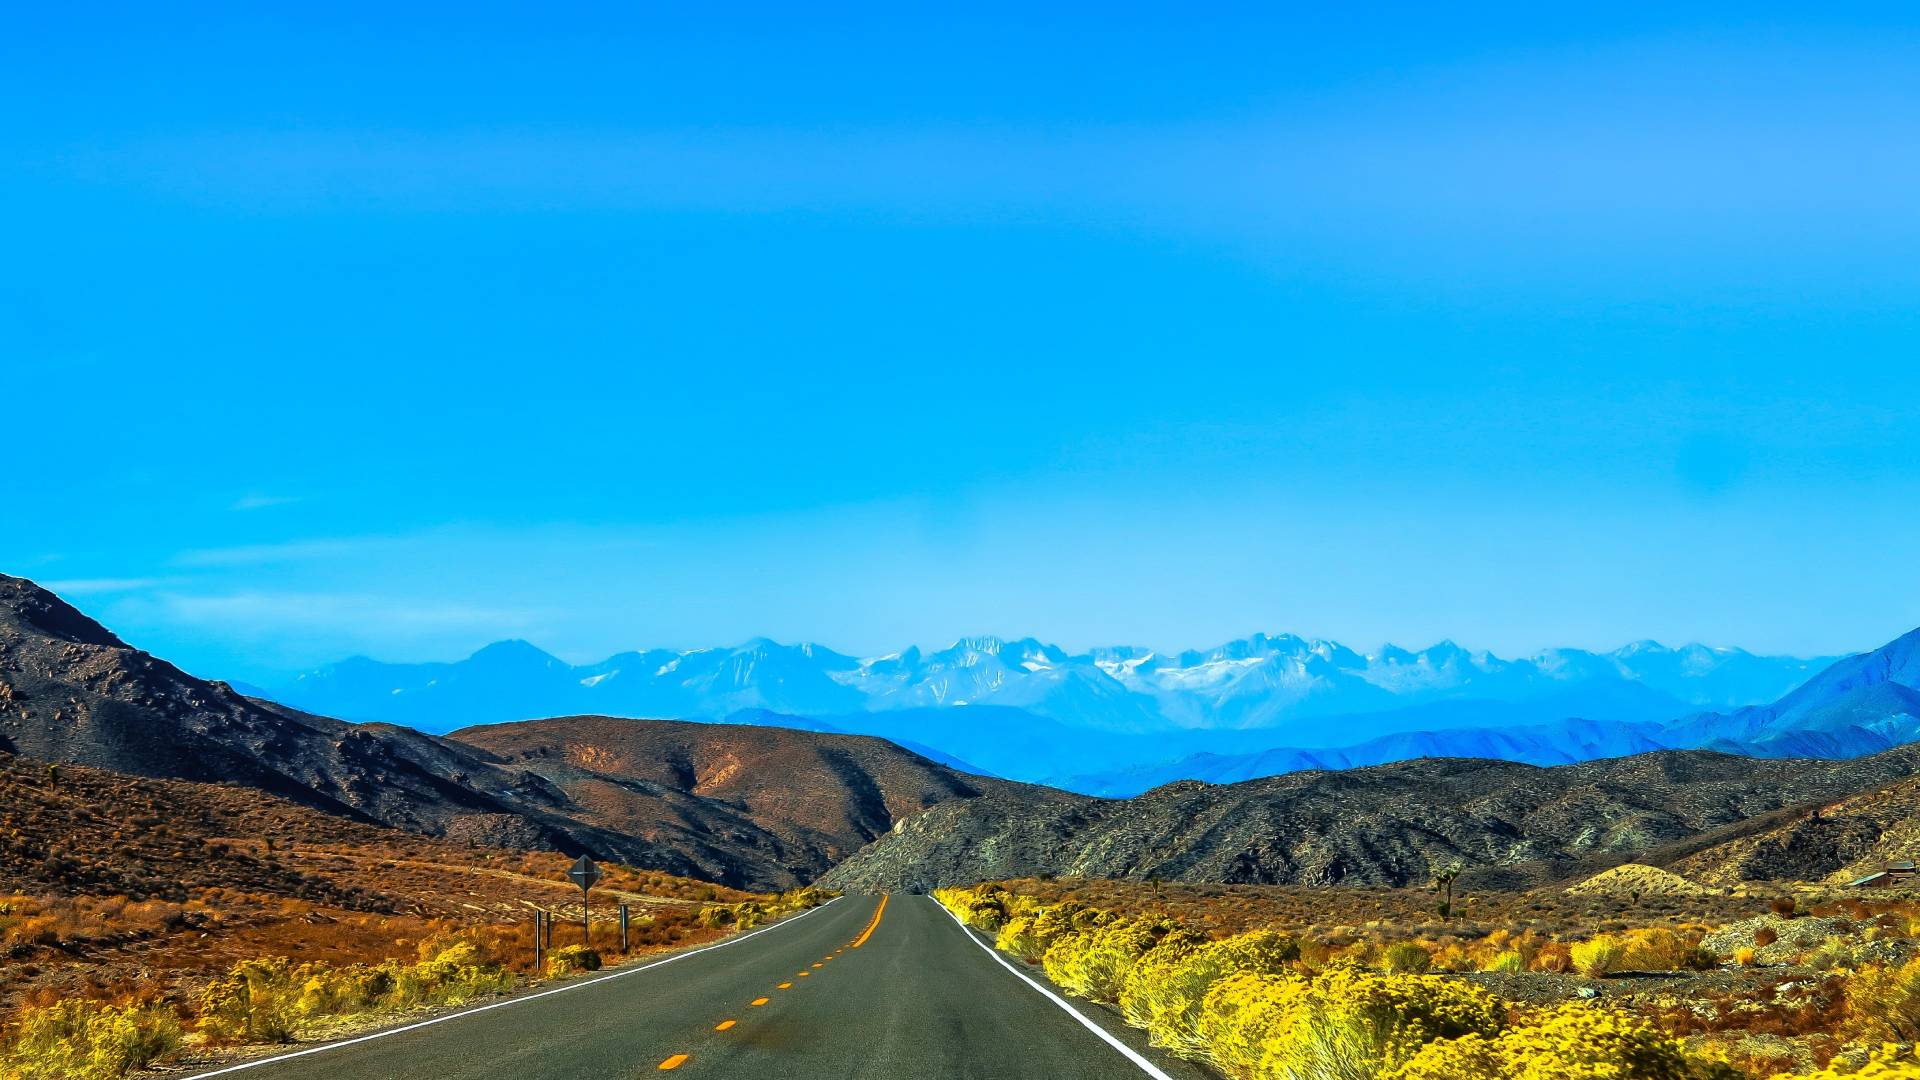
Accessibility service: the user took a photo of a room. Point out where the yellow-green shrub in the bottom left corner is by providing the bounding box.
[0,1001,180,1080]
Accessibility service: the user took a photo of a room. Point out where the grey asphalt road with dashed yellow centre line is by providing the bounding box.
[176,896,1204,1080]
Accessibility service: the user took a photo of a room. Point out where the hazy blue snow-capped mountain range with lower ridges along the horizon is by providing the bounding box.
[255,634,1830,796]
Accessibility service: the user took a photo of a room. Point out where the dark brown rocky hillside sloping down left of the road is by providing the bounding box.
[0,575,1044,888]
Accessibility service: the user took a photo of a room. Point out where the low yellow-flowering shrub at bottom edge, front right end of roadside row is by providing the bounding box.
[1386,1005,1741,1080]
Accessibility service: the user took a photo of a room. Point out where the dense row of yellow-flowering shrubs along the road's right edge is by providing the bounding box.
[935,882,1835,1080]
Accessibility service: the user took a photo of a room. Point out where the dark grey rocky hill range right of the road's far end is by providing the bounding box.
[824,749,1914,890]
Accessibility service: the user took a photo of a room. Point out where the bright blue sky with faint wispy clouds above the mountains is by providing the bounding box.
[0,4,1920,678]
